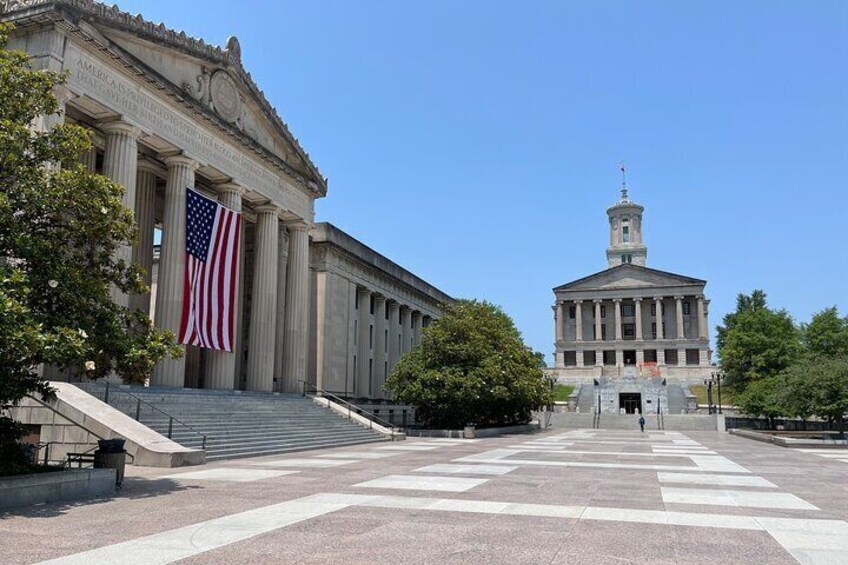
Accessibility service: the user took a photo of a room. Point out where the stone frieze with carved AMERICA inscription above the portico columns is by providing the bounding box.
[65,44,311,219]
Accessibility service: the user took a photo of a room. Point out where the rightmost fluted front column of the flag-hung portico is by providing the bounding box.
[282,221,309,392]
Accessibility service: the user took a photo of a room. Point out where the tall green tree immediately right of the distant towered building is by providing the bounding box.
[716,290,802,391]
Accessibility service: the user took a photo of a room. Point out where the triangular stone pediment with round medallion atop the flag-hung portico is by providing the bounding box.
[0,0,327,196]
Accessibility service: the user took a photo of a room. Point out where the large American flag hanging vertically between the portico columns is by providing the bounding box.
[180,189,241,351]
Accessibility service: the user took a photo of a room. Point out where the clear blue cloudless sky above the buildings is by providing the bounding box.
[118,0,848,360]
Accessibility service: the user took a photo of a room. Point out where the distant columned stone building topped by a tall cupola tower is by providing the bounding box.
[553,188,711,382]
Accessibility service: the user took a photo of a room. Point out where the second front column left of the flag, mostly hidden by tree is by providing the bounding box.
[100,121,141,306]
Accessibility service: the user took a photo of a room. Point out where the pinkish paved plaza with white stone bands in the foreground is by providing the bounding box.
[0,430,848,565]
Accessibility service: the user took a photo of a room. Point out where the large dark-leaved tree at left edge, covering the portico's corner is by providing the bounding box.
[0,25,179,470]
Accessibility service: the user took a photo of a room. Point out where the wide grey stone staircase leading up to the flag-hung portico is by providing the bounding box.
[77,383,385,461]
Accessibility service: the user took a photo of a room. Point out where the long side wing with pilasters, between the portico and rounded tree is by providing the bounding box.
[308,223,453,400]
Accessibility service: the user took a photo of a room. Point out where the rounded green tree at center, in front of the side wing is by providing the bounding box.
[386,300,553,428]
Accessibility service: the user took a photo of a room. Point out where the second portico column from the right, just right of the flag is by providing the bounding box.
[247,205,280,392]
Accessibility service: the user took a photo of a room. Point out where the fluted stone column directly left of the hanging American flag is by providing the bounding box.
[152,155,198,387]
